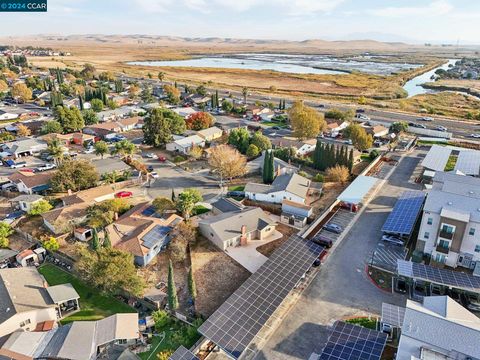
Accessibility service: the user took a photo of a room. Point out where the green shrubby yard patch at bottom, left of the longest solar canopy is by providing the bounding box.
[138,320,200,360]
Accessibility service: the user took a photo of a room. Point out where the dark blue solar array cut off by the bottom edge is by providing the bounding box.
[319,321,387,360]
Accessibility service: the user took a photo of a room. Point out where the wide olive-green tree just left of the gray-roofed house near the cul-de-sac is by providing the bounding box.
[50,160,99,192]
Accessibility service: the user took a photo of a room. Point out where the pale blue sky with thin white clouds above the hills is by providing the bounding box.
[0,0,480,44]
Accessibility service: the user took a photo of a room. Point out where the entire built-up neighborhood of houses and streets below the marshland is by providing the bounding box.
[0,27,480,360]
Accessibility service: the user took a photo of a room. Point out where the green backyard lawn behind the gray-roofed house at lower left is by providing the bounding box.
[38,264,135,323]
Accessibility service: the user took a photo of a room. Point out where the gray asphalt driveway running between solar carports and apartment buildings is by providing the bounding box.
[255,151,420,360]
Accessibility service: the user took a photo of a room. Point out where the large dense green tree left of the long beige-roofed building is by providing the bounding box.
[143,108,186,147]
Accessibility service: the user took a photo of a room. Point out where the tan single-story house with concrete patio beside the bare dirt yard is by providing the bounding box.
[198,207,276,250]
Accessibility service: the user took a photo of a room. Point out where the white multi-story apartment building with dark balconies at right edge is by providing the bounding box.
[416,171,480,269]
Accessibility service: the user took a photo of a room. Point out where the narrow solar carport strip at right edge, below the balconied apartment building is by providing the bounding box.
[397,260,480,292]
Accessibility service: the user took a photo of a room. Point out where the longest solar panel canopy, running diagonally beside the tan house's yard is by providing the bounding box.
[199,235,323,358]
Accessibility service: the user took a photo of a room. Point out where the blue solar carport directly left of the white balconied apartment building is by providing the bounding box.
[382,191,425,235]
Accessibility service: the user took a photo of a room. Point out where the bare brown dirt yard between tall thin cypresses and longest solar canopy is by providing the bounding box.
[189,237,250,316]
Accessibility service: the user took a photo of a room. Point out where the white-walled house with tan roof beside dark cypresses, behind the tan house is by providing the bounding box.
[244,174,310,204]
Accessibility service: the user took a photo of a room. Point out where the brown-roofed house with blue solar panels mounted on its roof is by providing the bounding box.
[105,202,183,266]
